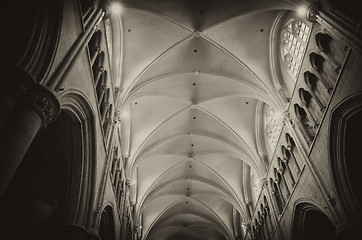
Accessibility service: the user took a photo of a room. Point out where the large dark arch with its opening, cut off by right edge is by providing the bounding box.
[329,93,362,234]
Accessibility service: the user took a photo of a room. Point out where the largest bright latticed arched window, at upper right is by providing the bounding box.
[281,19,310,81]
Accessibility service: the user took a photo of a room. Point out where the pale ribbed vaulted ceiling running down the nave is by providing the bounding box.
[117,0,302,240]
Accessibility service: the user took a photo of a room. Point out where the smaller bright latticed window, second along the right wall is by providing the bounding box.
[264,104,283,152]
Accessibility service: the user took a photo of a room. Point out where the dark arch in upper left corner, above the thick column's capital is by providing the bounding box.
[2,0,63,82]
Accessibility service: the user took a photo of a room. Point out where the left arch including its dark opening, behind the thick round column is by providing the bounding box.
[0,90,95,239]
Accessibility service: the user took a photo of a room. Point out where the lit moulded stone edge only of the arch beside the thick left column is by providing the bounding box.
[59,90,96,227]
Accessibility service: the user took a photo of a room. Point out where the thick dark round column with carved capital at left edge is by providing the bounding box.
[0,81,60,198]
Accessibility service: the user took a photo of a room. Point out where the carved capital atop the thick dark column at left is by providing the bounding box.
[24,84,60,129]
